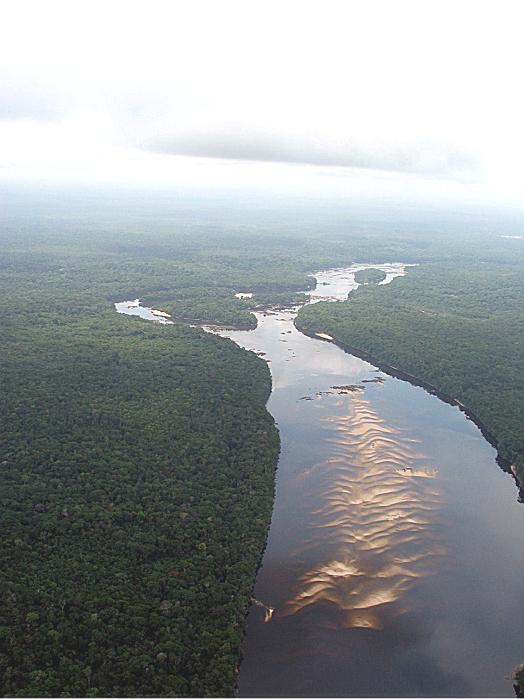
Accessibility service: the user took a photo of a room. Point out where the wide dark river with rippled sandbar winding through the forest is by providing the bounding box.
[117,264,524,697]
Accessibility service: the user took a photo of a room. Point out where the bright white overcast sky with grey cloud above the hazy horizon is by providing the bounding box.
[0,0,524,202]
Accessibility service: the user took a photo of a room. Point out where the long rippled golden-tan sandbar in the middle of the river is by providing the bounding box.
[277,394,446,629]
